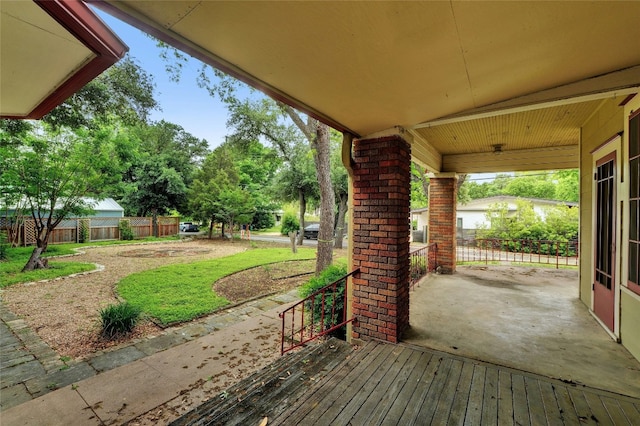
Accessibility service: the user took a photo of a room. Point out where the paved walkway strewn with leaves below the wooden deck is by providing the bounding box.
[0,290,298,426]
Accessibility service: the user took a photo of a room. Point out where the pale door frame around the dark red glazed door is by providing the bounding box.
[589,135,623,342]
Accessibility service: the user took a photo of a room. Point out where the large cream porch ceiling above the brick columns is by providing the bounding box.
[92,0,640,173]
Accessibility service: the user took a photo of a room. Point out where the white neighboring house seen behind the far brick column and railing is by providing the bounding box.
[411,195,578,241]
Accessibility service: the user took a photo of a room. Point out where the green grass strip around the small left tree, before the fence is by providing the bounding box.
[0,237,177,288]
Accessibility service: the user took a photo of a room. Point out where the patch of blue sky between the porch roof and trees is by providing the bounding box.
[94,9,229,148]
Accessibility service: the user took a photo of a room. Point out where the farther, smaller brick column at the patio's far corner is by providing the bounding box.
[429,176,458,274]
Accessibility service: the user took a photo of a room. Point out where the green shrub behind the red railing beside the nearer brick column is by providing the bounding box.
[299,265,347,339]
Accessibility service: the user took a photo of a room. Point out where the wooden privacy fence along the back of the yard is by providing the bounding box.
[0,217,180,246]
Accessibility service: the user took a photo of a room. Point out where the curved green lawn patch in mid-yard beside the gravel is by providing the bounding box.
[117,248,315,324]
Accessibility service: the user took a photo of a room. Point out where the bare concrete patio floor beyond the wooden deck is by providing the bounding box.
[403,266,640,398]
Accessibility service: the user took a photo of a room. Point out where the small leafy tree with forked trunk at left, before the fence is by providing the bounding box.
[2,125,127,270]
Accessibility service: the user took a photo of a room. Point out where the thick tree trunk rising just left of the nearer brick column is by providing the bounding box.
[312,122,336,275]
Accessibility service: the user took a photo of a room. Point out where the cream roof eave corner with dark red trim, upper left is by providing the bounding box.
[0,0,128,119]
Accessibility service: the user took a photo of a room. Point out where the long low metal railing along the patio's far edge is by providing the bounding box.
[456,239,579,268]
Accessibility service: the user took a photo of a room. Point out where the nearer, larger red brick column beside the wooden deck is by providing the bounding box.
[349,135,411,343]
